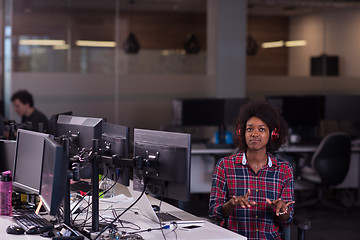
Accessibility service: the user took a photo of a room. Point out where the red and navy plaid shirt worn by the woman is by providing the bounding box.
[209,152,294,239]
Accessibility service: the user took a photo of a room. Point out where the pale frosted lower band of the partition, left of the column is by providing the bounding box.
[10,73,216,129]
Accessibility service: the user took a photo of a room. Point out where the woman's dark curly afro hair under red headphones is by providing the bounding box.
[234,101,288,152]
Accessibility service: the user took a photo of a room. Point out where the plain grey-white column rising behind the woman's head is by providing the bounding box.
[207,0,247,98]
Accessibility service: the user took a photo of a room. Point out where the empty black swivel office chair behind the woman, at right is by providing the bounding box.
[295,132,351,212]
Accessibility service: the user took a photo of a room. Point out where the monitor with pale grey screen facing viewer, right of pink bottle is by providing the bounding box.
[13,129,49,194]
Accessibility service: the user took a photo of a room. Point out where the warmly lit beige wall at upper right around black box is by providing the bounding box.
[289,9,360,77]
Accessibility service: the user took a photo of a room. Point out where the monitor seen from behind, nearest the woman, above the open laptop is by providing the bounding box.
[133,129,191,201]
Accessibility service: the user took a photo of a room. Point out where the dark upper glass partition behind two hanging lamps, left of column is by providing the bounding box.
[9,0,206,74]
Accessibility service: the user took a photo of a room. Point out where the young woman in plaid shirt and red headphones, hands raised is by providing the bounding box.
[209,102,295,239]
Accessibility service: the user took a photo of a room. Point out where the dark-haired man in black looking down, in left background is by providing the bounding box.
[11,90,48,132]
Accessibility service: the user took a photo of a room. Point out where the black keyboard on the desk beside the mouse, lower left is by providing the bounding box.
[13,213,54,234]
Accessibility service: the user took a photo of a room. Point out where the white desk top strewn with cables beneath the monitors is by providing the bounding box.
[0,184,246,240]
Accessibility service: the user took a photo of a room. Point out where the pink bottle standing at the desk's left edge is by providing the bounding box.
[0,171,12,215]
